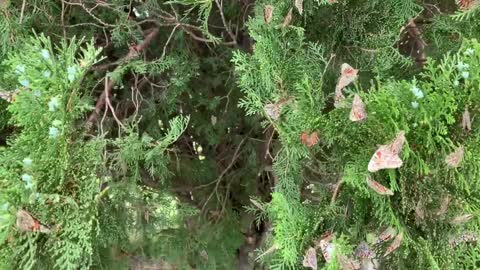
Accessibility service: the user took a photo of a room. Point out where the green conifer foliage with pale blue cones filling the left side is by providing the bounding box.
[0,36,193,269]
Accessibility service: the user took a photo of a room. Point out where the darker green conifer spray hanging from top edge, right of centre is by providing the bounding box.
[304,0,422,76]
